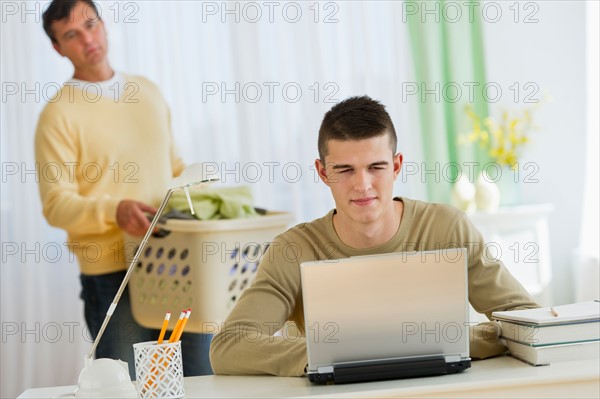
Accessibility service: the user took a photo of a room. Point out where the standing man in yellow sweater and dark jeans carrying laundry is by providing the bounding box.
[35,0,211,376]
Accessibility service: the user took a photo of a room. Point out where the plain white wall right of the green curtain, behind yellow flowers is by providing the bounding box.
[483,1,598,304]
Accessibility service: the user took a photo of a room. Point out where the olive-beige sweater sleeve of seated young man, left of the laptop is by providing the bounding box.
[210,236,307,376]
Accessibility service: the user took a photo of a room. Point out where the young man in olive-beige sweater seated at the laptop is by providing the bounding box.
[210,97,538,376]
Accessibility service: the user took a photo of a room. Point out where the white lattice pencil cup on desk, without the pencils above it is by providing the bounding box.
[133,341,185,398]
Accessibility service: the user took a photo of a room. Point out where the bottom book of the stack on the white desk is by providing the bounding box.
[506,341,600,366]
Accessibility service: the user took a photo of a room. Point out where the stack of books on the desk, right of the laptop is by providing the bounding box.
[492,301,600,366]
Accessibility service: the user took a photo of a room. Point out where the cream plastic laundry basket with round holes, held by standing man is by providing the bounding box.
[125,212,293,333]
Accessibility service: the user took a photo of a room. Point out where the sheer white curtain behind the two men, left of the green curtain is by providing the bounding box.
[1,1,424,397]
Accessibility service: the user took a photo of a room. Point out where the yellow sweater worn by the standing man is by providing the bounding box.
[35,75,184,275]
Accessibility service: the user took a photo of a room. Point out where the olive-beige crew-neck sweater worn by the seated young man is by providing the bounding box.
[210,198,538,376]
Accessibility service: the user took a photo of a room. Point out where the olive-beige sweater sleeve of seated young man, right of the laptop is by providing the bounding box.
[449,213,539,359]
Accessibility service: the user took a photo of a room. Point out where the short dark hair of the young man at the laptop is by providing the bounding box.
[318,96,398,162]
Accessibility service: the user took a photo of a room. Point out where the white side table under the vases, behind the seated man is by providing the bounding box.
[470,204,554,305]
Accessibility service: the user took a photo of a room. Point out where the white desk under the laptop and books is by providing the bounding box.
[19,357,600,398]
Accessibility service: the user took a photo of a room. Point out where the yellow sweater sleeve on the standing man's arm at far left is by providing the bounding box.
[35,108,121,235]
